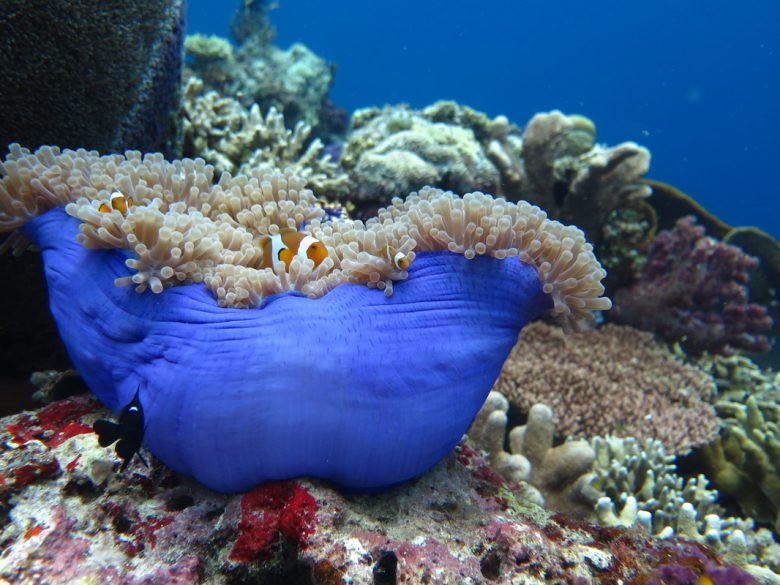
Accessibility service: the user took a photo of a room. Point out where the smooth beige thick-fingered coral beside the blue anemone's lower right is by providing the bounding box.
[468,391,599,518]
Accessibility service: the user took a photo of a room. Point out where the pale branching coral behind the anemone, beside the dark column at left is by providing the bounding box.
[182,77,348,195]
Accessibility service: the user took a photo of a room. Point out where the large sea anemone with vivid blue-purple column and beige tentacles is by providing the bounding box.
[0,146,610,491]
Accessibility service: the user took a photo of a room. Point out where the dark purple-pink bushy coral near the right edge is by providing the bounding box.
[613,216,772,354]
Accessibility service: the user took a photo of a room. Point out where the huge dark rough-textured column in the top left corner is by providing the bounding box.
[0,0,184,156]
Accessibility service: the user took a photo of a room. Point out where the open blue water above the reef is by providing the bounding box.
[188,0,780,237]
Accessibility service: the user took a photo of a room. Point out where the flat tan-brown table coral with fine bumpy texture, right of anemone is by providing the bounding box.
[495,322,718,454]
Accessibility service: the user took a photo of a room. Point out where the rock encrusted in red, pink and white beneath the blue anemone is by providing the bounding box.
[0,399,753,585]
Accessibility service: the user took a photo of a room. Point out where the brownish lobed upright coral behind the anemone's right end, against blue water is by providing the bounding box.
[519,110,650,241]
